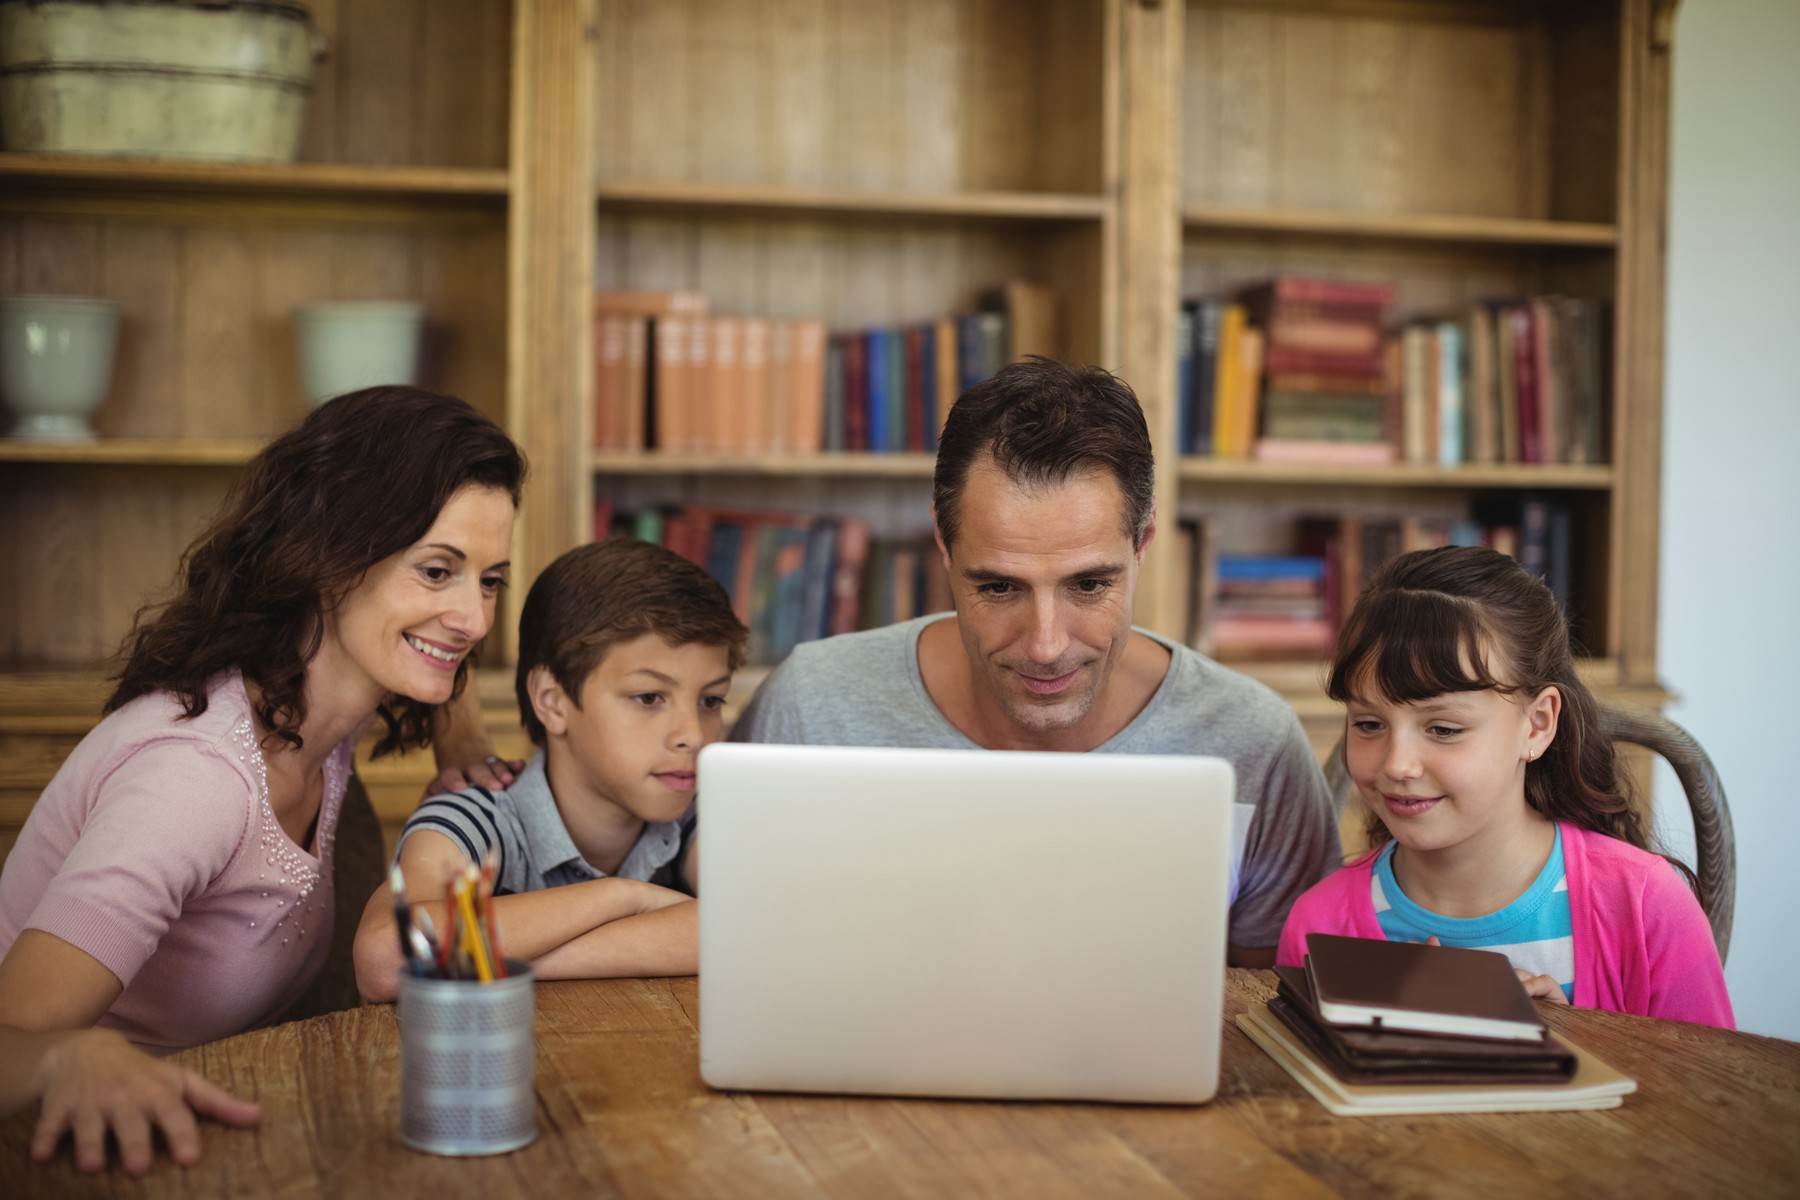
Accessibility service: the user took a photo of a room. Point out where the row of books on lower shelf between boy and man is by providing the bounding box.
[594,502,950,664]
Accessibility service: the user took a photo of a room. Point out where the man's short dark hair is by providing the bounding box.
[931,356,1156,547]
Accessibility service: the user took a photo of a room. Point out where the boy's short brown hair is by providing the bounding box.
[513,538,749,745]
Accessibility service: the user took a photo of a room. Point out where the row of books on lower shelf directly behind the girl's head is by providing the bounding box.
[1177,497,1582,660]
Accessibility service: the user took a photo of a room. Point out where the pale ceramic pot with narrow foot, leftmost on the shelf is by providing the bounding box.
[0,295,119,441]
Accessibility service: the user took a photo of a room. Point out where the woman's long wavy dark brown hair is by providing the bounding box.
[106,387,526,754]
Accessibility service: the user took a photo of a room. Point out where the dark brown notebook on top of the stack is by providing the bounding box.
[1307,934,1546,1042]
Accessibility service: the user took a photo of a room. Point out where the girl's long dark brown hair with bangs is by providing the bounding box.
[1325,547,1656,863]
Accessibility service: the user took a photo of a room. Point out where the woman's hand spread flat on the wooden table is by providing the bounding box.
[31,1029,263,1175]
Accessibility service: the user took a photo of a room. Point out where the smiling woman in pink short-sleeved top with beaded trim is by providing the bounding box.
[0,387,526,1173]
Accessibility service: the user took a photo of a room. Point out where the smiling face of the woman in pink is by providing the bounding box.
[324,484,513,703]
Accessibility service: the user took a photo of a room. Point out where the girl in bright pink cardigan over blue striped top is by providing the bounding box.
[1278,547,1733,1029]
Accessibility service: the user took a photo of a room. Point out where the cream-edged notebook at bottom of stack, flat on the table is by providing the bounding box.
[1237,1004,1638,1117]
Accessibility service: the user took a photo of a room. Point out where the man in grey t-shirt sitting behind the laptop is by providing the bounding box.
[733,358,1339,966]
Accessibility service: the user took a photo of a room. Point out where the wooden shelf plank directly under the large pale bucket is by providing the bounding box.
[0,153,509,200]
